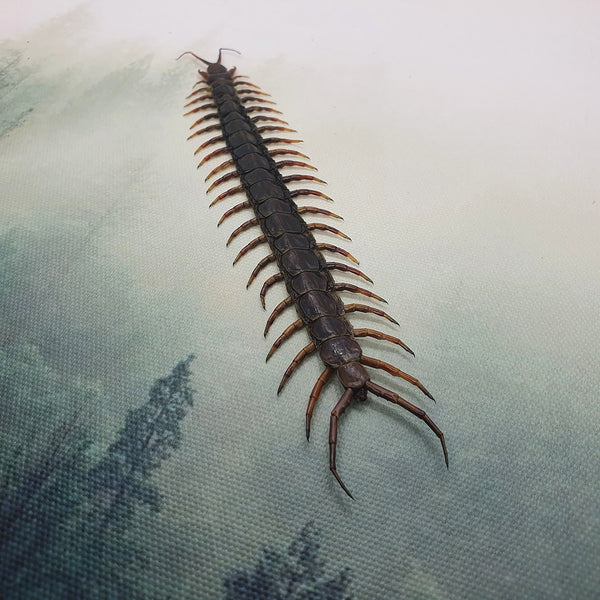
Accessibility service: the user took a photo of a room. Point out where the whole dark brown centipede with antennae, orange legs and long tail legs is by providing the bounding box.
[179,48,448,498]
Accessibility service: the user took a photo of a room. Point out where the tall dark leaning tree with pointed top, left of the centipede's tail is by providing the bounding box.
[88,355,194,527]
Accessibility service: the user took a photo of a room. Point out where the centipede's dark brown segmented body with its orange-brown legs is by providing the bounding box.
[180,53,447,495]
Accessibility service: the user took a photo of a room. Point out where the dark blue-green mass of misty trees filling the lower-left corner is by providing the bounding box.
[0,356,193,600]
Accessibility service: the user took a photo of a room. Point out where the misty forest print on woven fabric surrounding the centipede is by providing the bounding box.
[0,0,600,600]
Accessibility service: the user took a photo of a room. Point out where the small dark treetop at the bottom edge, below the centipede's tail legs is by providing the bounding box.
[224,522,351,600]
